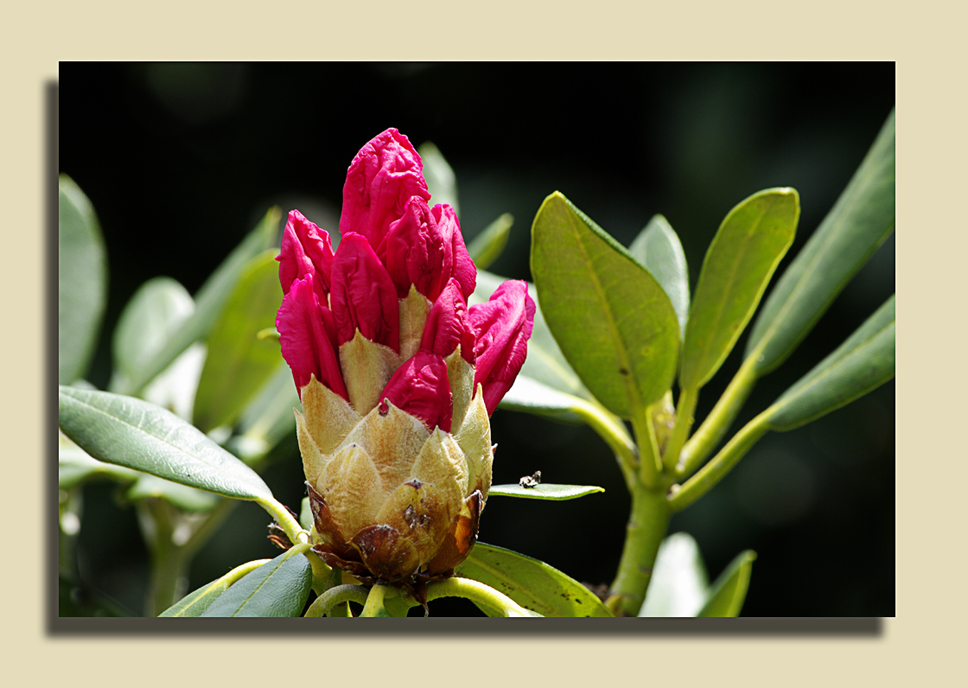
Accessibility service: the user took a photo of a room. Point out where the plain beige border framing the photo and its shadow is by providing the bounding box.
[7,0,966,686]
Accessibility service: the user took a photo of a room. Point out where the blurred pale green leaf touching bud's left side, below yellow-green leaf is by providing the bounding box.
[229,357,299,463]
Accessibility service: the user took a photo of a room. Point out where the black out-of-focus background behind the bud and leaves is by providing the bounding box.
[57,63,895,616]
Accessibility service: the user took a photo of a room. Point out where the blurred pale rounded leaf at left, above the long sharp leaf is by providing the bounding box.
[110,277,195,391]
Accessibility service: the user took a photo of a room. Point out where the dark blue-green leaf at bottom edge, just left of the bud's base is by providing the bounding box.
[200,552,313,617]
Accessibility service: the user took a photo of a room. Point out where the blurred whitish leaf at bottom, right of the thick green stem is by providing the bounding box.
[639,533,709,617]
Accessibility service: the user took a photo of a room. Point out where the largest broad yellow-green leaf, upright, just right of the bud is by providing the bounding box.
[531,192,679,418]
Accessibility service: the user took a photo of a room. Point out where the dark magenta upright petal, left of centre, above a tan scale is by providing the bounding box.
[330,232,400,351]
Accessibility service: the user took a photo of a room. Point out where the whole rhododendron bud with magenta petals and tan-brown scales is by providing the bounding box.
[276,129,535,599]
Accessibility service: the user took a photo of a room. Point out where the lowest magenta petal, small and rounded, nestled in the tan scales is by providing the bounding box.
[380,351,453,432]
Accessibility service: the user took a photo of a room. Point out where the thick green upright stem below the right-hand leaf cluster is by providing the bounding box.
[606,485,671,616]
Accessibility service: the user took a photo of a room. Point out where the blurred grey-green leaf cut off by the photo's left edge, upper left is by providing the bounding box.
[57,174,108,384]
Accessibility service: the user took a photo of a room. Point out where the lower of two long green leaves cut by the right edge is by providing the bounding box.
[765,295,894,430]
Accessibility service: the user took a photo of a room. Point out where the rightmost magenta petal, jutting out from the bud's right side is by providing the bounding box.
[468,280,535,414]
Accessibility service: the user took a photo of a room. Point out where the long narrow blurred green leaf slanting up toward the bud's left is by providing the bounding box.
[118,208,280,394]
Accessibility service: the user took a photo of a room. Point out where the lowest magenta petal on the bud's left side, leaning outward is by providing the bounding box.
[276,275,349,401]
